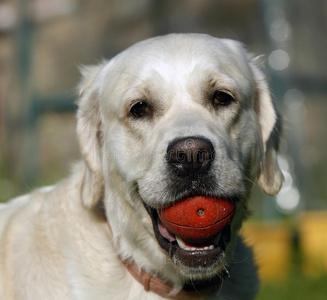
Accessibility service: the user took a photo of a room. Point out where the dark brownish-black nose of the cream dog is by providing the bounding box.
[167,137,215,177]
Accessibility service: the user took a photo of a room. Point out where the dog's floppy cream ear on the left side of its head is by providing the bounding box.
[76,65,104,208]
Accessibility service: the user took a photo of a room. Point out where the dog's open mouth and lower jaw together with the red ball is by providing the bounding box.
[148,196,235,274]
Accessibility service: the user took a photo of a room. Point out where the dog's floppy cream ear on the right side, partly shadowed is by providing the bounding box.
[251,64,284,196]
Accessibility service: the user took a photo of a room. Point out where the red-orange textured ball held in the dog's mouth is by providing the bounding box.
[159,196,235,244]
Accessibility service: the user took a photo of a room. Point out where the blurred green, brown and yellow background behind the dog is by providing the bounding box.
[0,0,327,300]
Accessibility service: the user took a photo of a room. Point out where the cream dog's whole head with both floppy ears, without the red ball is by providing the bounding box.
[77,34,282,283]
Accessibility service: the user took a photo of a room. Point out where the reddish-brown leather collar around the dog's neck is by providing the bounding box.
[107,222,223,300]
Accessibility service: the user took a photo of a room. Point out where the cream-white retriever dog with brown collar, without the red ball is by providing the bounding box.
[0,34,283,300]
